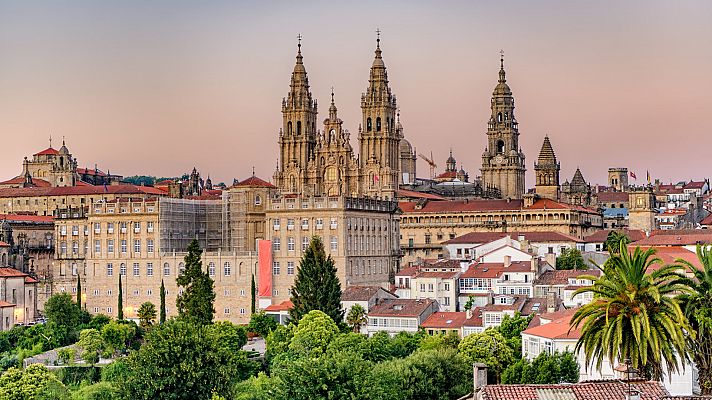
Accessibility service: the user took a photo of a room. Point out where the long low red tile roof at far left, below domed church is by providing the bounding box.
[0,185,165,198]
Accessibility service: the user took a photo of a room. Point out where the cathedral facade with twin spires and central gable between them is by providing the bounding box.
[274,37,416,199]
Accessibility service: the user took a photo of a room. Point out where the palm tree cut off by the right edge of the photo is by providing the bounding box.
[677,245,712,395]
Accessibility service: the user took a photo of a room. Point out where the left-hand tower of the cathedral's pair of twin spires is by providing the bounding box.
[274,37,317,194]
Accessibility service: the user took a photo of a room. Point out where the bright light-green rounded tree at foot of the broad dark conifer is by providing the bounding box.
[289,310,339,356]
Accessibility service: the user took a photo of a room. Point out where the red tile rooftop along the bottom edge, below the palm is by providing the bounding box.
[483,380,668,400]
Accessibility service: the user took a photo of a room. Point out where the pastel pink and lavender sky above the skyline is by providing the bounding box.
[0,0,712,187]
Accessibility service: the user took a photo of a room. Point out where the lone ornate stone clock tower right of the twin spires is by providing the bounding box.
[480,57,526,199]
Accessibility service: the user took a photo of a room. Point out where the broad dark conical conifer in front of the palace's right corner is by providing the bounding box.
[289,236,344,324]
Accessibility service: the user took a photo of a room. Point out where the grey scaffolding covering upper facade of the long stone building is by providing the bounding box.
[159,197,230,252]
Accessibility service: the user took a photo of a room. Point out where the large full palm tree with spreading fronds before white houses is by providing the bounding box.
[571,241,690,380]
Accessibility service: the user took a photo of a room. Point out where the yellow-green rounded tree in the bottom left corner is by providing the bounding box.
[0,364,69,400]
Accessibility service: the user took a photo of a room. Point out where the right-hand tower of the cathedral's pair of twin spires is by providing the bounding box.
[359,32,403,199]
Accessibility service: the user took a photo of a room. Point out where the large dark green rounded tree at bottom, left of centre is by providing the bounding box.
[116,319,246,400]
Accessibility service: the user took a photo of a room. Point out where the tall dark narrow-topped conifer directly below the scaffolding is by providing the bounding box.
[176,239,215,325]
